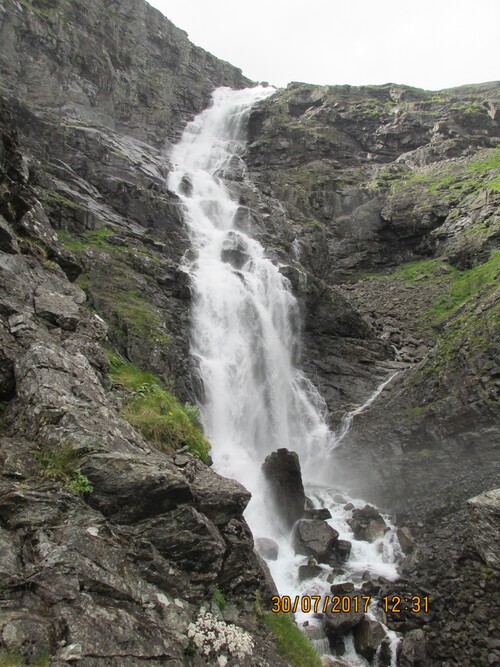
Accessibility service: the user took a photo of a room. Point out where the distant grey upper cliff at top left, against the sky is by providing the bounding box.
[0,0,250,146]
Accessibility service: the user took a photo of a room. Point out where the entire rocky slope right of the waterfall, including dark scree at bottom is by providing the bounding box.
[241,83,500,665]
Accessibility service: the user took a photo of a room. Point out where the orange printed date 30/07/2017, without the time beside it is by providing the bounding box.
[271,595,372,614]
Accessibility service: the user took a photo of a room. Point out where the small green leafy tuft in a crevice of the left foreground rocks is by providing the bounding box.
[34,440,93,493]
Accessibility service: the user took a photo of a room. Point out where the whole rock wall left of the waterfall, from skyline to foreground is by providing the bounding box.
[0,2,290,667]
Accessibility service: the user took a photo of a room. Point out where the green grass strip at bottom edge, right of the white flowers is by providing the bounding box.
[264,612,321,667]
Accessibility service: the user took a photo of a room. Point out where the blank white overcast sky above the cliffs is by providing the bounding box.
[149,0,500,90]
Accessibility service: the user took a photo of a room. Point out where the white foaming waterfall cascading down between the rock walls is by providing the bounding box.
[169,87,396,664]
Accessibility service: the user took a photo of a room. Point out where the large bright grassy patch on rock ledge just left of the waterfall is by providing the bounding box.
[108,351,210,463]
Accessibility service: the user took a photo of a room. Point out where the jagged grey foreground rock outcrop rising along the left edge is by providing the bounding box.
[0,94,284,666]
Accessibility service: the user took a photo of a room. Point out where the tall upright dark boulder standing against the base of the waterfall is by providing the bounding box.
[262,449,306,528]
